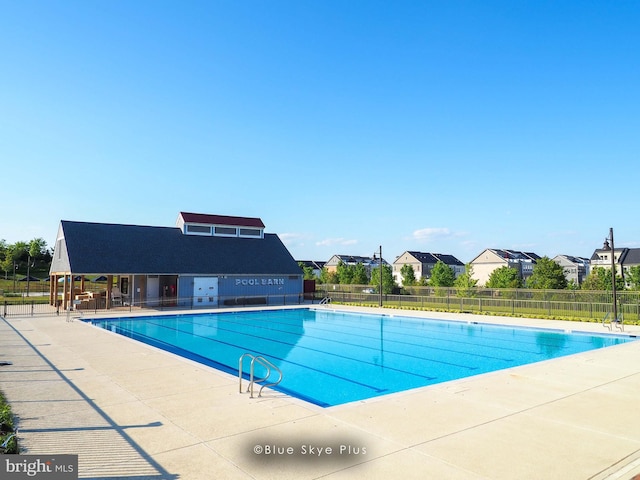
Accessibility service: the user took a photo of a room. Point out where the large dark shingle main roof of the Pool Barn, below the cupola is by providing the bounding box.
[51,220,301,275]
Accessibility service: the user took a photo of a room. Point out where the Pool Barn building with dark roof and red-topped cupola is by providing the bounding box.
[49,212,303,309]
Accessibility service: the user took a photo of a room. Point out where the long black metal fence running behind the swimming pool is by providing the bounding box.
[6,284,640,323]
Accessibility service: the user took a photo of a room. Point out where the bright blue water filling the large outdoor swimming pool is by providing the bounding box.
[92,309,635,406]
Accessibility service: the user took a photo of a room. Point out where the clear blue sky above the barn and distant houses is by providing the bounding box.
[0,0,640,262]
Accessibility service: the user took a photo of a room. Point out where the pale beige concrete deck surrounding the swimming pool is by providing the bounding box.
[0,307,640,480]
